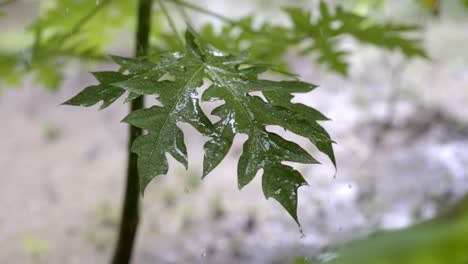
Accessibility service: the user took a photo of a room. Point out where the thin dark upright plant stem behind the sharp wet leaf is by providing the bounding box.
[112,0,153,264]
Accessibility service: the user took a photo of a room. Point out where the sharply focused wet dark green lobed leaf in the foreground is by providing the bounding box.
[66,30,335,222]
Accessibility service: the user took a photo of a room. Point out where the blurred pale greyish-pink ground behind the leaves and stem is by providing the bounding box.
[0,0,468,264]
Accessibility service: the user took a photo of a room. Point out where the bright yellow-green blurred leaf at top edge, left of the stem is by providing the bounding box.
[30,0,136,53]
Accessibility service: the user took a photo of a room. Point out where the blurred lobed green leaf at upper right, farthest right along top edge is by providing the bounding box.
[285,1,427,74]
